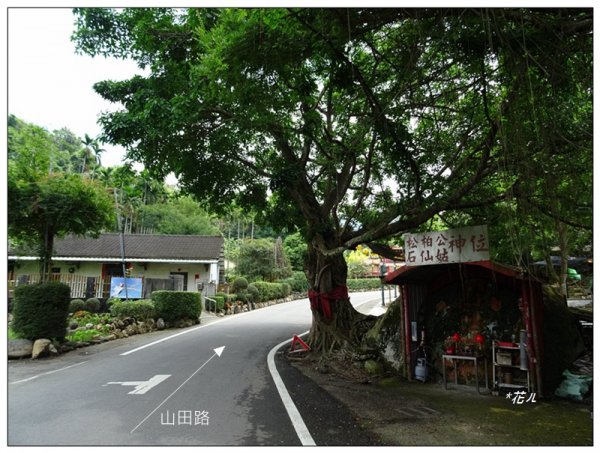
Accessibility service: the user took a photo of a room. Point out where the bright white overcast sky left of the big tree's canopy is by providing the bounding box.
[7,8,142,166]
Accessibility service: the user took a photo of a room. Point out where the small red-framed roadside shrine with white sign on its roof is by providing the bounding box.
[385,227,544,394]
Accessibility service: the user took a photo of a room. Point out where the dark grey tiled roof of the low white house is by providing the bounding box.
[9,233,223,260]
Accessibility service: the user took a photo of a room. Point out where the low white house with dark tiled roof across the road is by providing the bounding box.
[8,233,223,298]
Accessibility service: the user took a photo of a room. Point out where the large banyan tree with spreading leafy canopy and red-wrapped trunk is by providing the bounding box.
[73,8,593,350]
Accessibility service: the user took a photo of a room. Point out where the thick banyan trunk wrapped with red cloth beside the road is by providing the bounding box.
[306,244,374,354]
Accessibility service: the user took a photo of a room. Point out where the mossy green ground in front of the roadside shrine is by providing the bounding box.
[378,378,593,446]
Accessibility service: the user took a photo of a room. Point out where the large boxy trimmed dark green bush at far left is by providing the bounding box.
[12,282,71,340]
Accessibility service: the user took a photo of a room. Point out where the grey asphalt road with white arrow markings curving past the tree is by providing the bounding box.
[8,292,380,446]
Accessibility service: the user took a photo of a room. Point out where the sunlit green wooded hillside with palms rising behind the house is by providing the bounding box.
[8,115,258,240]
